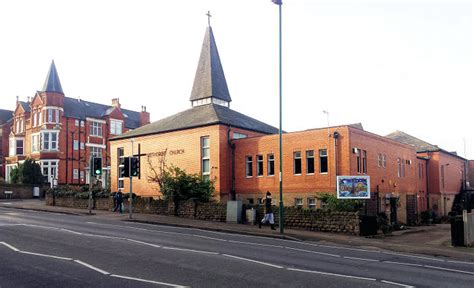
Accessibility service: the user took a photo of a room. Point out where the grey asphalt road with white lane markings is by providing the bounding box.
[0,208,474,288]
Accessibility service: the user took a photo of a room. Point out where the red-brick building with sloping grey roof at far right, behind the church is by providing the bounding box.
[387,131,468,216]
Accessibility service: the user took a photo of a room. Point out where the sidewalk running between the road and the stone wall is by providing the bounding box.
[0,199,474,261]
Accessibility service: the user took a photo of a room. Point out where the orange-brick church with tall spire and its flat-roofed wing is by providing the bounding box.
[110,23,426,222]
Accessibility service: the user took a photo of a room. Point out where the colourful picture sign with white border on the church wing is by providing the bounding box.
[337,176,370,199]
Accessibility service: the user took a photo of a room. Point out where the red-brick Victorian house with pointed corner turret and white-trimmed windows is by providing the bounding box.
[5,61,150,184]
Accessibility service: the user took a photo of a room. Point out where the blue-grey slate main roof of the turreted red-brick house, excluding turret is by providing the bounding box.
[64,97,140,129]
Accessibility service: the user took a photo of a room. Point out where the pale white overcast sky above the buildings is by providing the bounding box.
[0,0,474,159]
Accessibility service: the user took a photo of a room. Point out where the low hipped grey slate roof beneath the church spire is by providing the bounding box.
[111,104,278,140]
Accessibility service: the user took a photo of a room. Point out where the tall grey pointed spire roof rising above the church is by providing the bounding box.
[189,26,232,102]
